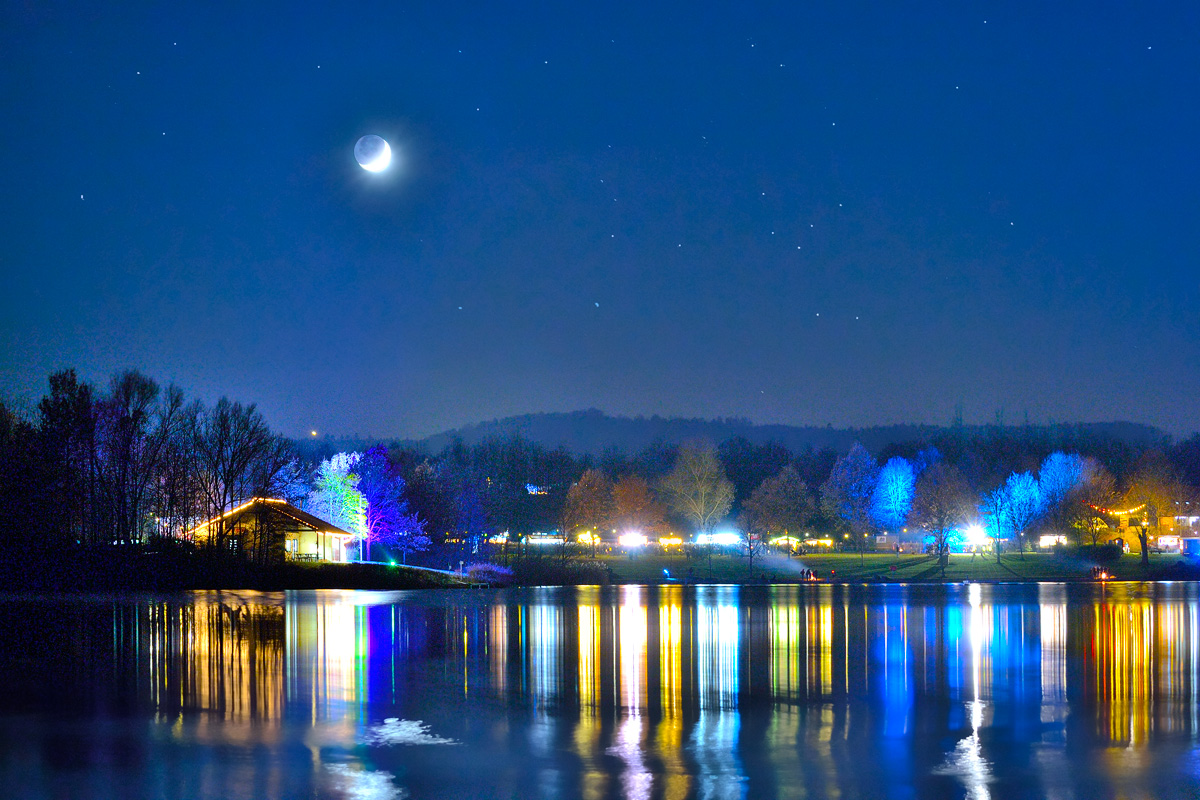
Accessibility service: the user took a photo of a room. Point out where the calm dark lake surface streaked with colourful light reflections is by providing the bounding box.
[0,583,1200,800]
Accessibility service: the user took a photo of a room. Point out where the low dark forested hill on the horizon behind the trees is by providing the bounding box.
[413,409,1168,455]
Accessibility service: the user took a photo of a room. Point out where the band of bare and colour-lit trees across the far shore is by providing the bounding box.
[0,371,1200,575]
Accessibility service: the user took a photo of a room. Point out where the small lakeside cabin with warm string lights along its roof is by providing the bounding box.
[192,498,353,561]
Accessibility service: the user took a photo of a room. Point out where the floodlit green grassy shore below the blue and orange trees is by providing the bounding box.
[588,553,1200,583]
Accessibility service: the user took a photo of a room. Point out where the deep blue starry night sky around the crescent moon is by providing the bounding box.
[0,1,1200,435]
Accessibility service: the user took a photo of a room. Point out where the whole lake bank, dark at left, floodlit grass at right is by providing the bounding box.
[9,548,1200,591]
